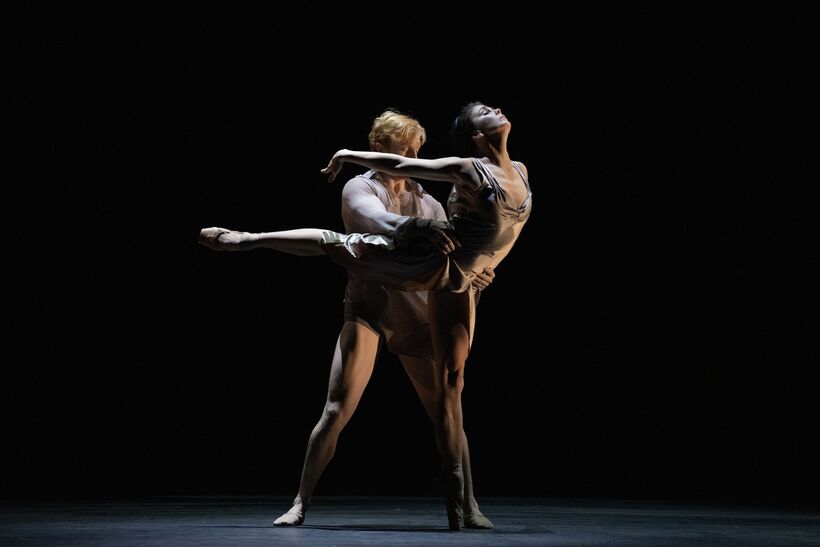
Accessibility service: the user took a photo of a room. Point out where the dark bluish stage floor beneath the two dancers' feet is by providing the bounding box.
[0,497,820,546]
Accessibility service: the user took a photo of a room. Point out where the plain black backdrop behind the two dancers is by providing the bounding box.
[0,2,820,503]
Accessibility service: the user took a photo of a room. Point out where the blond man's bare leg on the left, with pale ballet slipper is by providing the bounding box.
[273,321,379,526]
